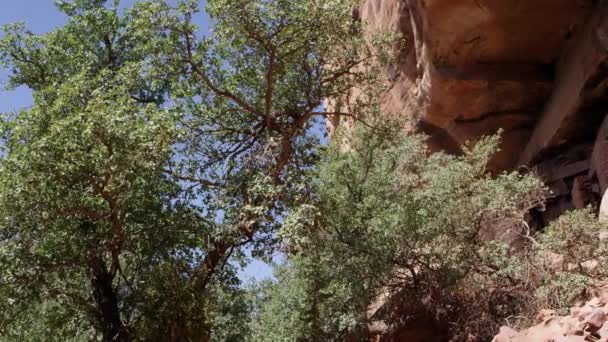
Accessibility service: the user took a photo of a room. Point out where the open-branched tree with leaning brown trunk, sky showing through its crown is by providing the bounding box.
[157,0,390,288]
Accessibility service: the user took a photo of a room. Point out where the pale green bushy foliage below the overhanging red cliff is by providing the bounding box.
[254,125,607,341]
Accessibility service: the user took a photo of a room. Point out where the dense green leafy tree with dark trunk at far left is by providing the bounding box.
[0,1,188,341]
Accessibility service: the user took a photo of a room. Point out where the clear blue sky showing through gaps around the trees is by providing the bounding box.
[0,0,272,280]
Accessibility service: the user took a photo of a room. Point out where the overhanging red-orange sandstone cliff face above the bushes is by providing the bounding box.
[358,0,608,176]
